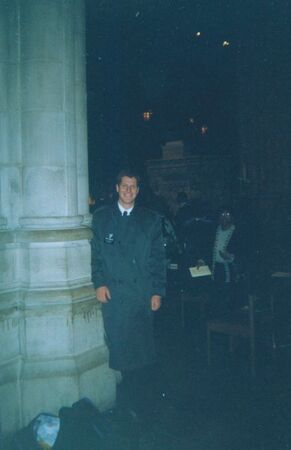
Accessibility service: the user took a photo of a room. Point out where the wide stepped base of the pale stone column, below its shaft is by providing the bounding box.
[0,228,116,435]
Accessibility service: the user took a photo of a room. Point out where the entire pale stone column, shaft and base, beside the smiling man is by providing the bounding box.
[0,0,115,434]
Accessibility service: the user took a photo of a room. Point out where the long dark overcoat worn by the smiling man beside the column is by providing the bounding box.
[91,204,166,371]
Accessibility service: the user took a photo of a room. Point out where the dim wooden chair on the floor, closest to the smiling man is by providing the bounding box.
[207,295,272,376]
